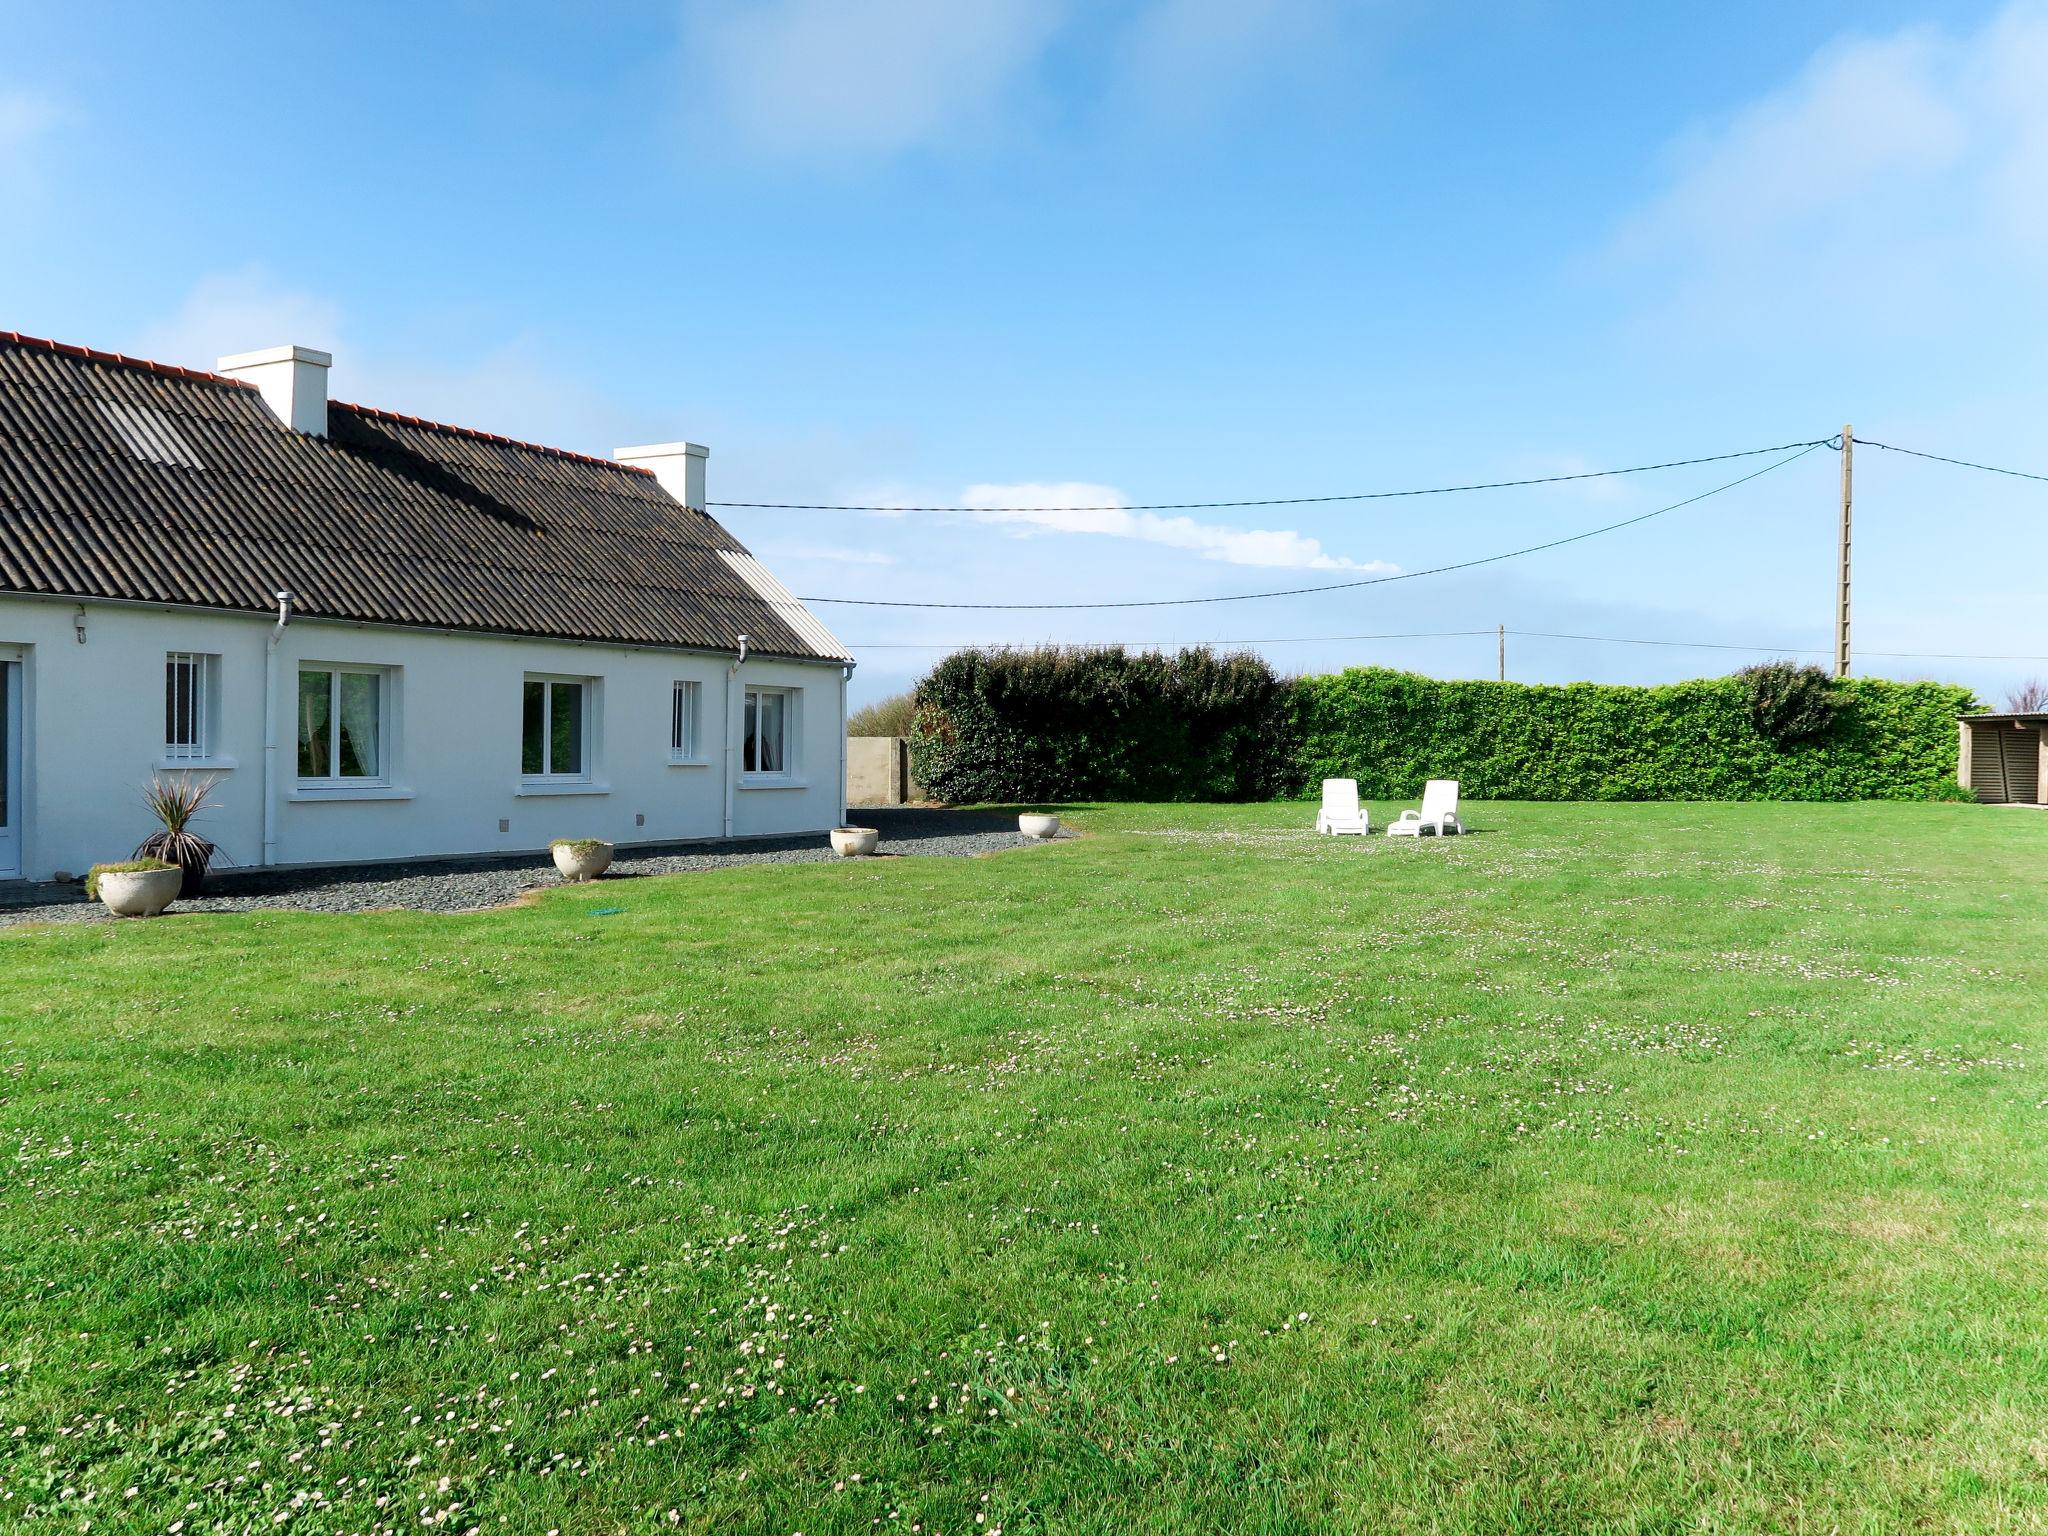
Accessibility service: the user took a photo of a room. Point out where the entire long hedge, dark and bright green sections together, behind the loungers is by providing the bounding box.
[911,647,1974,803]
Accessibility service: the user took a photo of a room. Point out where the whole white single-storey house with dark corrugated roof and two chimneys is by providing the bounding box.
[0,332,852,879]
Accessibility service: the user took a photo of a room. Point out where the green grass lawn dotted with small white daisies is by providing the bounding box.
[0,805,2048,1536]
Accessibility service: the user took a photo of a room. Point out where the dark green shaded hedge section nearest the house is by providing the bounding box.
[909,647,1296,803]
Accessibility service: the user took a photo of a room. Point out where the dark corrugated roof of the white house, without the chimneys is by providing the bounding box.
[0,332,846,659]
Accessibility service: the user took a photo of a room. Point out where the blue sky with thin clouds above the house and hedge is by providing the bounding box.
[0,0,2048,698]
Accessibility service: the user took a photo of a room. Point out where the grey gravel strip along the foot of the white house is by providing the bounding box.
[0,807,1071,928]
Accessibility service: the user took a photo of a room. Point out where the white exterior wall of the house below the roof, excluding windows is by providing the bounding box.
[0,594,846,879]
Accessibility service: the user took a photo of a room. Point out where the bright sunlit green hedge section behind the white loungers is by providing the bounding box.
[1292,668,1974,801]
